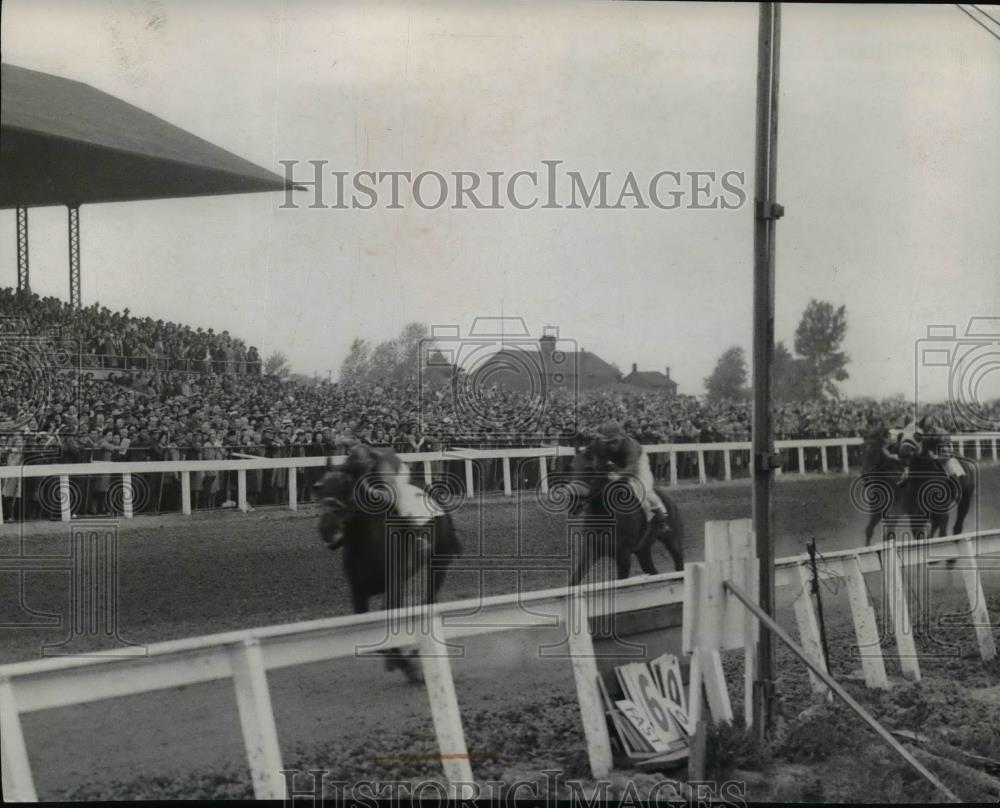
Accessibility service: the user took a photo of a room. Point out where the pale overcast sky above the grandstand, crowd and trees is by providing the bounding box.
[0,0,1000,397]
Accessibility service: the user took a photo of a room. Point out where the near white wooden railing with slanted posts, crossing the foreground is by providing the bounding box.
[0,520,1000,801]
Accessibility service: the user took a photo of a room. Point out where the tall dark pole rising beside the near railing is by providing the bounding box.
[753,3,784,741]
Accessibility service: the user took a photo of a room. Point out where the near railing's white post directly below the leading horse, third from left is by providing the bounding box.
[419,615,474,798]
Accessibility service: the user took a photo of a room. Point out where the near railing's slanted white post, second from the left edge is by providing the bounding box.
[230,638,285,800]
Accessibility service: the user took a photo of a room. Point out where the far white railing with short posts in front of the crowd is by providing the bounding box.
[0,433,1000,524]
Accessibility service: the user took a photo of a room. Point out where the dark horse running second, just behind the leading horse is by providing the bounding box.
[567,469,684,586]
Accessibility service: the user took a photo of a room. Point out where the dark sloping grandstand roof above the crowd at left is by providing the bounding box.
[0,64,296,208]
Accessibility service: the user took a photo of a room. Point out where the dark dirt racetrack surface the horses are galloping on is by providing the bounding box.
[0,466,1000,799]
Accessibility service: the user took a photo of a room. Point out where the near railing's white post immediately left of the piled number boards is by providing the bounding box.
[565,594,613,780]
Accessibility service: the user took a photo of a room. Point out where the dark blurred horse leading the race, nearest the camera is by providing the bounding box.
[314,444,462,682]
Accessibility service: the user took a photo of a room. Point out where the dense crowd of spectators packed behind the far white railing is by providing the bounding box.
[0,290,1000,518]
